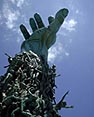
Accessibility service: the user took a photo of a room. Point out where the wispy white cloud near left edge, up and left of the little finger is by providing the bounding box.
[3,3,20,29]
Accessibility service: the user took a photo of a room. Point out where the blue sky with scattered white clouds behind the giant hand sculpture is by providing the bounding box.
[0,0,94,117]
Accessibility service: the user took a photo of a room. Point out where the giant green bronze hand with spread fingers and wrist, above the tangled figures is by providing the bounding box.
[20,8,68,61]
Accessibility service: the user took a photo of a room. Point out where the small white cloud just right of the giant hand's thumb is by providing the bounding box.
[62,19,77,32]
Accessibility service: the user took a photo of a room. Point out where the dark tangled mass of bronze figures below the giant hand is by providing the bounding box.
[0,51,60,117]
